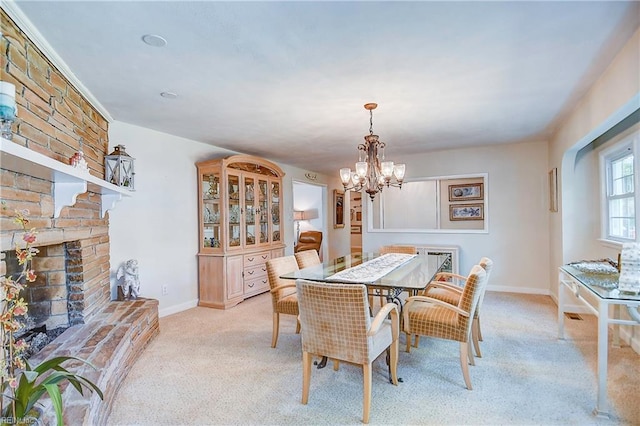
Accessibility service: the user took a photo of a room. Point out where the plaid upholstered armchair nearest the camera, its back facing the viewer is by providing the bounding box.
[296,280,400,423]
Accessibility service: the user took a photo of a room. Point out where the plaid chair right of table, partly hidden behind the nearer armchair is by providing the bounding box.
[422,257,493,358]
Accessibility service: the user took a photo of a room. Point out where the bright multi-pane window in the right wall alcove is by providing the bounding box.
[601,128,640,242]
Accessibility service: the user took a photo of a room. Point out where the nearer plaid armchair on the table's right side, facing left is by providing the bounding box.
[403,265,487,390]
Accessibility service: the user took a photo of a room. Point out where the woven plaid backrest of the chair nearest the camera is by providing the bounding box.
[296,280,373,364]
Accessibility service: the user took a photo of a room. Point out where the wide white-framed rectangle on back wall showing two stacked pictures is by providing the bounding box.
[365,173,489,233]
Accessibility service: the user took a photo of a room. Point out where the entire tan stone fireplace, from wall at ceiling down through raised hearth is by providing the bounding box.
[0,7,159,425]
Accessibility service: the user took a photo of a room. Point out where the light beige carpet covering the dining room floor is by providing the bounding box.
[108,293,640,425]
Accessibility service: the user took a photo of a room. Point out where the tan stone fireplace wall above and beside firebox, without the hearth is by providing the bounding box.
[0,9,110,320]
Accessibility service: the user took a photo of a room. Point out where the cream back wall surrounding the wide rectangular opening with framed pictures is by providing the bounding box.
[363,142,550,294]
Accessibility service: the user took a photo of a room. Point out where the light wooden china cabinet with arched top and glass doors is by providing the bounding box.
[196,155,285,309]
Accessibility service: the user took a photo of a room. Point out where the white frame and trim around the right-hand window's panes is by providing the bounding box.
[599,130,640,245]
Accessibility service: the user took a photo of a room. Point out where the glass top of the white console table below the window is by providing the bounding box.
[560,259,640,300]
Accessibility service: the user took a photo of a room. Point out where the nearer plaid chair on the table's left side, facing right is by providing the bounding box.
[267,255,300,348]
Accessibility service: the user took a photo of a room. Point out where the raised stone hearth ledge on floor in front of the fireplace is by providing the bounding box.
[29,299,160,426]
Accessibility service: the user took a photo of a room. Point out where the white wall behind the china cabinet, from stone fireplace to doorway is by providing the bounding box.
[109,122,340,316]
